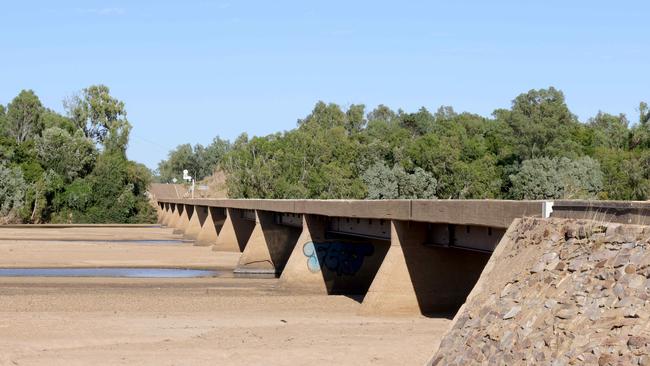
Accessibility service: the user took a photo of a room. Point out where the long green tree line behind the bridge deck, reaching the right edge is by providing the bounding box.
[157,87,650,200]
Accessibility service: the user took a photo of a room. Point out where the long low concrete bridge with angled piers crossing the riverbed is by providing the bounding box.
[157,198,650,314]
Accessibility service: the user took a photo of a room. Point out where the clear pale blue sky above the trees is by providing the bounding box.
[0,0,650,168]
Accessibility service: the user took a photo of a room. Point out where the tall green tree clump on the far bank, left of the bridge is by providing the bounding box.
[0,85,155,223]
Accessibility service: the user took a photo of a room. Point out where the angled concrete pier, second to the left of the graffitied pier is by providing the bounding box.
[212,208,255,252]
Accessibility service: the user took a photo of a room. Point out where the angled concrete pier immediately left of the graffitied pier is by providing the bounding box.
[235,210,302,275]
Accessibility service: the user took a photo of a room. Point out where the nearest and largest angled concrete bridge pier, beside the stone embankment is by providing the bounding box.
[360,220,489,315]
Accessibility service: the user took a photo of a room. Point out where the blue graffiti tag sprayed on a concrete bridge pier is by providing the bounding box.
[302,241,375,276]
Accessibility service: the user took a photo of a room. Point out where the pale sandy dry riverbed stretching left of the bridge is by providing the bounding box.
[0,224,449,365]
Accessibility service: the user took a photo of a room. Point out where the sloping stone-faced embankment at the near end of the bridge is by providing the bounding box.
[430,219,650,365]
